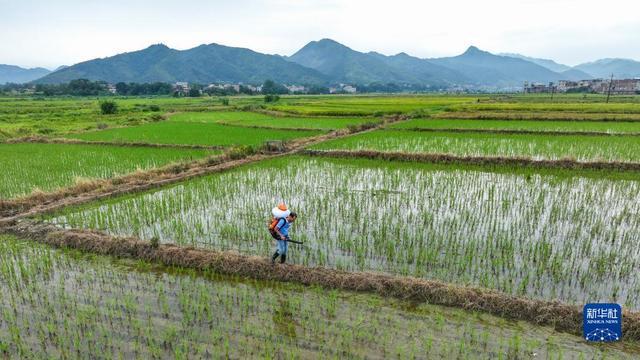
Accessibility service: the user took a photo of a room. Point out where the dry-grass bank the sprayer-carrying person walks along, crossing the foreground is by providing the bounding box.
[0,220,640,341]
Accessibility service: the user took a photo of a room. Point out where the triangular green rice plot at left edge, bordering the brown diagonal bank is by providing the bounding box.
[0,143,214,198]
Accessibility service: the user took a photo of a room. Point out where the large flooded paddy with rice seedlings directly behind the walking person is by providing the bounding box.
[51,157,640,309]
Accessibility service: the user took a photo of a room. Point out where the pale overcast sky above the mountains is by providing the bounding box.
[0,0,640,68]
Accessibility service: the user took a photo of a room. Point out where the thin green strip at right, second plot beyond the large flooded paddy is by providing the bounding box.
[389,119,640,134]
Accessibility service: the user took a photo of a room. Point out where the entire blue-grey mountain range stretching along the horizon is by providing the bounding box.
[5,39,640,89]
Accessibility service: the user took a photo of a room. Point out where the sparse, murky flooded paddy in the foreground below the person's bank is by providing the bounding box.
[0,236,637,359]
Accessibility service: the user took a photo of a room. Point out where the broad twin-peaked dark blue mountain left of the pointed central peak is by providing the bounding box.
[32,44,327,84]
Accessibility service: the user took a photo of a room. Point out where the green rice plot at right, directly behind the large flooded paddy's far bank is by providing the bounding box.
[312,130,640,162]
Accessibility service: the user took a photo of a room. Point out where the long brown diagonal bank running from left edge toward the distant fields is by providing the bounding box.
[0,117,405,224]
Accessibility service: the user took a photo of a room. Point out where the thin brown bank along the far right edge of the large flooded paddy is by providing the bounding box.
[299,149,640,171]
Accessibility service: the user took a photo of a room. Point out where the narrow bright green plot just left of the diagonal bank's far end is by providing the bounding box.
[170,111,380,130]
